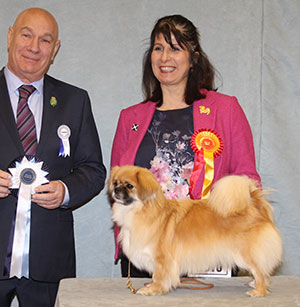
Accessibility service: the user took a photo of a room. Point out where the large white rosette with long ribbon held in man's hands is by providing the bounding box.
[9,157,48,278]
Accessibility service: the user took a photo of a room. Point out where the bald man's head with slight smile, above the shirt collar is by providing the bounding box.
[8,9,60,83]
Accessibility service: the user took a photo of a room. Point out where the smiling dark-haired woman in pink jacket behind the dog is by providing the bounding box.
[111,15,260,277]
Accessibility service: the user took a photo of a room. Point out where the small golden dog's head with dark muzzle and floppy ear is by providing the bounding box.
[108,165,161,206]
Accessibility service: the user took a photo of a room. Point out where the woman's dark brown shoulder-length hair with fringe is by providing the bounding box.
[143,15,215,106]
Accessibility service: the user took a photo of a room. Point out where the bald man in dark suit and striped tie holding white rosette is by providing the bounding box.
[0,8,106,307]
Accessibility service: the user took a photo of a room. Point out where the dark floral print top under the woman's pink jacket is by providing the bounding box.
[135,106,194,199]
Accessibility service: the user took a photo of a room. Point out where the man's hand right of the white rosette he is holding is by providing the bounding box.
[32,180,65,209]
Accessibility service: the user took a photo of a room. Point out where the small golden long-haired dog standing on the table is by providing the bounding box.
[107,165,282,297]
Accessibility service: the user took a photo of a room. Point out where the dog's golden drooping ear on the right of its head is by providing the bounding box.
[136,169,161,201]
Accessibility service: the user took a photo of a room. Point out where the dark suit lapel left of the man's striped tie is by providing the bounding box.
[0,70,24,155]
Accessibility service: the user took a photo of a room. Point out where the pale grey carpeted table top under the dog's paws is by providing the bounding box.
[55,275,300,307]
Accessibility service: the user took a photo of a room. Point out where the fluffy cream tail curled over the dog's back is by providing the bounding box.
[208,175,273,220]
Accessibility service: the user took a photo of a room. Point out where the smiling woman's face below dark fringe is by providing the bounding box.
[151,34,191,89]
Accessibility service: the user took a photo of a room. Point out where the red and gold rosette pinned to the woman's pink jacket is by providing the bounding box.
[190,129,223,199]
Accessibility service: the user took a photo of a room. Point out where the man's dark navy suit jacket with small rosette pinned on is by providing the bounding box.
[0,70,106,282]
